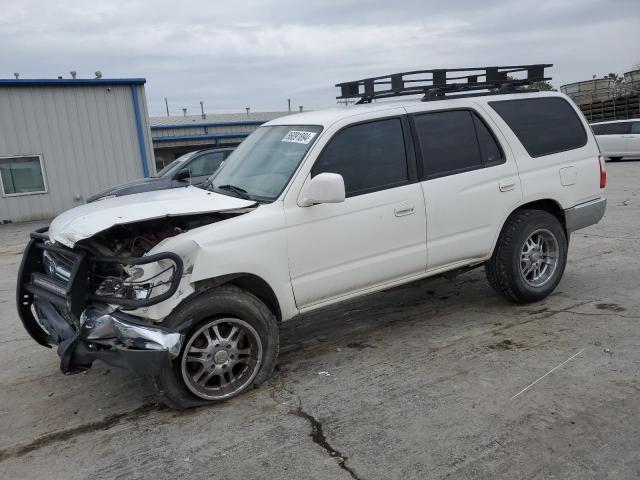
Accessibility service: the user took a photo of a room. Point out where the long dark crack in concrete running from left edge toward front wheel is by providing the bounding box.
[0,403,166,462]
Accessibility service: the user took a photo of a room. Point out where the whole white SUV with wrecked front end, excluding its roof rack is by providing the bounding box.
[18,65,606,408]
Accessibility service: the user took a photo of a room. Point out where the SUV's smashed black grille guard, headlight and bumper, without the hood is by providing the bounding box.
[17,229,188,374]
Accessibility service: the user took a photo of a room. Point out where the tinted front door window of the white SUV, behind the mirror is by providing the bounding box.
[311,118,409,197]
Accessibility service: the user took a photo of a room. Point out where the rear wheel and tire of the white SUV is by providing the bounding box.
[485,210,568,303]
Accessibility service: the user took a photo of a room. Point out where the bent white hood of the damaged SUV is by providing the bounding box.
[49,187,255,248]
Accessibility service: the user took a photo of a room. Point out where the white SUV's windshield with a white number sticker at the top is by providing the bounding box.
[210,125,322,202]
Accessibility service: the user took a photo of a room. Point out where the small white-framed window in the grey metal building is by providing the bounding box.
[0,155,47,195]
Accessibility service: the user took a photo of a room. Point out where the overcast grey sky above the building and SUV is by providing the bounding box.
[0,0,640,115]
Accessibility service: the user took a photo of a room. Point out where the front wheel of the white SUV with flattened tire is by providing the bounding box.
[150,285,279,409]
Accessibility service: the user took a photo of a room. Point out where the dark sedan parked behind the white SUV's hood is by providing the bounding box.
[87,148,233,203]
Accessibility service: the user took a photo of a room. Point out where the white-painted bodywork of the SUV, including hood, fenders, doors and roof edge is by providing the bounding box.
[43,92,603,321]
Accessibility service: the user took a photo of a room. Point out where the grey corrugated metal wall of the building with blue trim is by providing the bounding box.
[0,84,155,222]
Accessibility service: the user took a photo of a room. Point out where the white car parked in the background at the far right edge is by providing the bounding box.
[591,118,640,160]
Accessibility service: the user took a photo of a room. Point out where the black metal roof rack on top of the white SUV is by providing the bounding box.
[336,63,553,104]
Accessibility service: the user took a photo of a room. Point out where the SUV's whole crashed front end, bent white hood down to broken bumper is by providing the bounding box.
[16,187,257,374]
